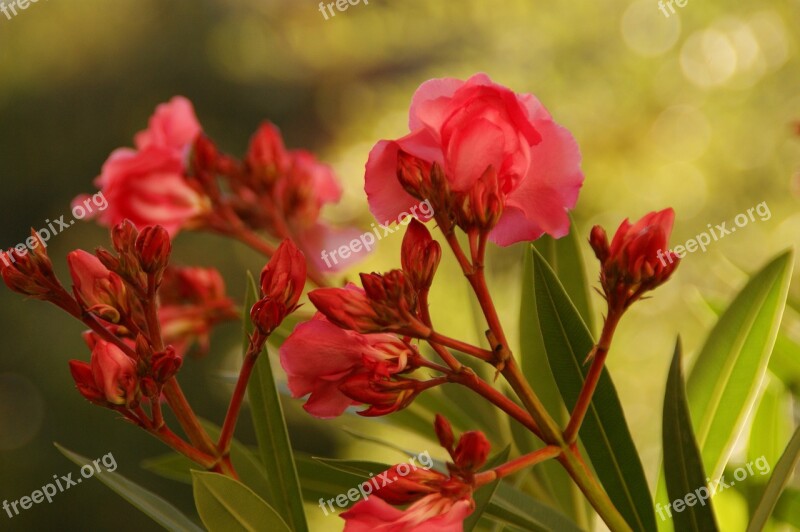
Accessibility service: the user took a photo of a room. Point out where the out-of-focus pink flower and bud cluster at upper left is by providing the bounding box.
[75,97,356,284]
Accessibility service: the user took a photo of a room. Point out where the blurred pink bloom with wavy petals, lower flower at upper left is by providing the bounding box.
[83,146,210,236]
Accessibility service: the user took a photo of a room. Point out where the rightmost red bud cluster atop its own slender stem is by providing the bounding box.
[589,209,680,315]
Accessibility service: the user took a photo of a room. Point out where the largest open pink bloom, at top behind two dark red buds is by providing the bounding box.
[365,74,583,246]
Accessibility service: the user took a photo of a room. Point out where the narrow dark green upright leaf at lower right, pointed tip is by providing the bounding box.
[661,339,719,532]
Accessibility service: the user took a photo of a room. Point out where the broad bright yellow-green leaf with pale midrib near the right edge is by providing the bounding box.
[687,252,793,479]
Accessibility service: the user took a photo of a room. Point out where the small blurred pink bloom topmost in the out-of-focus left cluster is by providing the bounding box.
[134,96,203,157]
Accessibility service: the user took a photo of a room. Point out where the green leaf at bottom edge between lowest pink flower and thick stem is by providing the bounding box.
[484,482,581,532]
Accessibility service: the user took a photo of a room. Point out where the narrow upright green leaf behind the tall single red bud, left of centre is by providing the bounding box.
[243,273,308,532]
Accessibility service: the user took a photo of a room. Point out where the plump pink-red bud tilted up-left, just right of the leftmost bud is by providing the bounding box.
[67,249,128,323]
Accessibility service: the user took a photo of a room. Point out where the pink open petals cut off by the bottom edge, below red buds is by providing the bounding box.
[342,493,475,532]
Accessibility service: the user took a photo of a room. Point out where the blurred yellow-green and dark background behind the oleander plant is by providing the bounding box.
[0,0,800,530]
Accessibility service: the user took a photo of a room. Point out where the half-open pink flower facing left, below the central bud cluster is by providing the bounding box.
[280,313,416,418]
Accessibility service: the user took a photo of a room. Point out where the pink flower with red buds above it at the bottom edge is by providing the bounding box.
[342,415,490,531]
